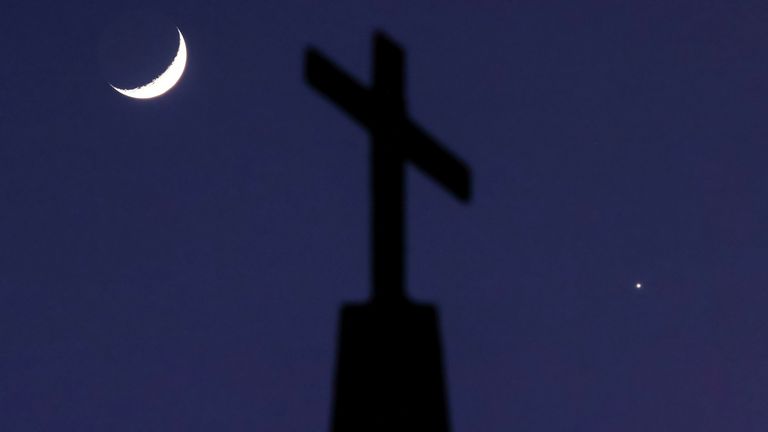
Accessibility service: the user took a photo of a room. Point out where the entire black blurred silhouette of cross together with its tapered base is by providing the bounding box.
[305,33,470,432]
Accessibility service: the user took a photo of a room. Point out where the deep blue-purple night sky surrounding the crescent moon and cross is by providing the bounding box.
[0,0,768,432]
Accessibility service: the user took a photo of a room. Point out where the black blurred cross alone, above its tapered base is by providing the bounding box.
[304,33,470,301]
